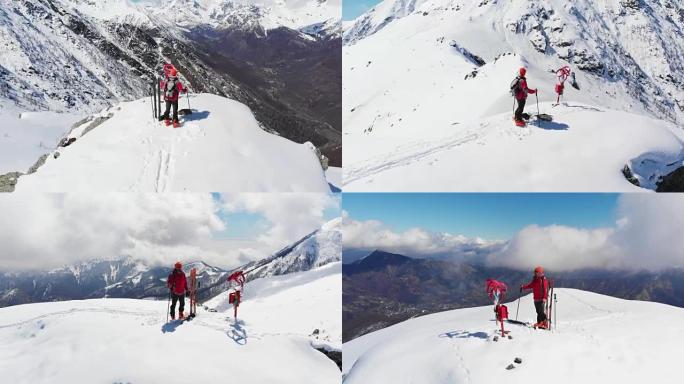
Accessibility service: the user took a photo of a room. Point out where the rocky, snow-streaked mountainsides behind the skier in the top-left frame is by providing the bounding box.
[0,0,341,172]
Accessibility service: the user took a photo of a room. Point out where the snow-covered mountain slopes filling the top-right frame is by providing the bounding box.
[343,0,684,191]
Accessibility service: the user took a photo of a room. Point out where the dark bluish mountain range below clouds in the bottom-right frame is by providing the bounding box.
[342,250,684,342]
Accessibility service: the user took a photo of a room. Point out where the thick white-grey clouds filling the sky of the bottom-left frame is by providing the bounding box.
[0,194,339,270]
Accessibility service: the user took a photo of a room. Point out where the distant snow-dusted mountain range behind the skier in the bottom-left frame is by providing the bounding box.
[0,219,341,307]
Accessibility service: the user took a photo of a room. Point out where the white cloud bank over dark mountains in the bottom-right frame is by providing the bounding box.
[343,193,684,271]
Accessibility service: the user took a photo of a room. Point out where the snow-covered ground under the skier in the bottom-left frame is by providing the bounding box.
[0,263,342,384]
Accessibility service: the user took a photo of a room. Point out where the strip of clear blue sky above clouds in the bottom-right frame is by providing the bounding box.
[342,193,619,240]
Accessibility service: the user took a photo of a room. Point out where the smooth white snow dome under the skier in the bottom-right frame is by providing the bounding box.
[343,289,684,384]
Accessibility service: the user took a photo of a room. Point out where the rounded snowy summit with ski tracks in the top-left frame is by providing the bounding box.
[16,94,330,192]
